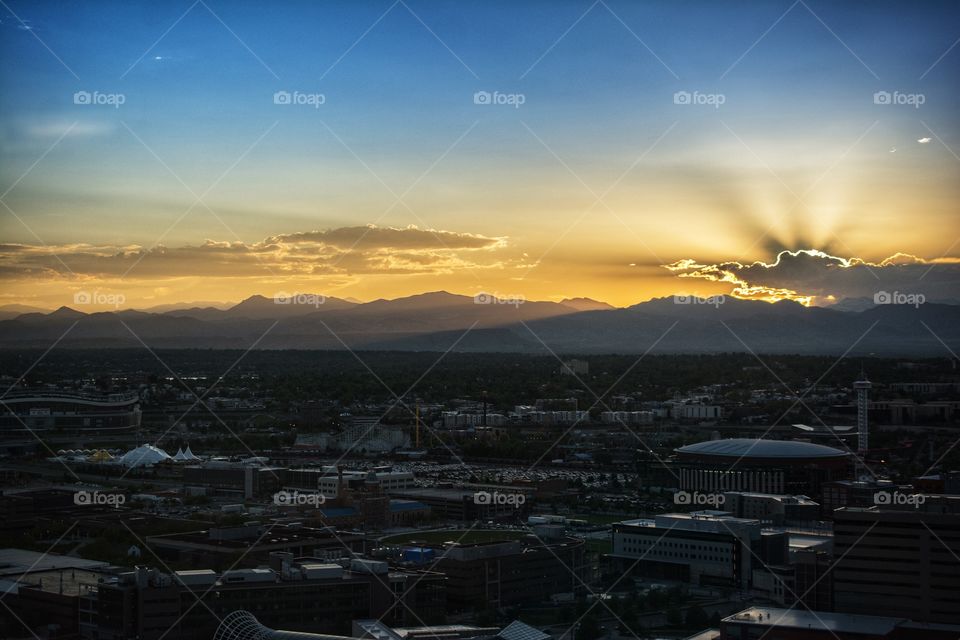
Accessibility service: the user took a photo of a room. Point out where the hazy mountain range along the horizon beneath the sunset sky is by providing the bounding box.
[0,291,960,356]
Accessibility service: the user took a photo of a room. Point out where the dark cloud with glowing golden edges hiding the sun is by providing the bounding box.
[661,249,960,305]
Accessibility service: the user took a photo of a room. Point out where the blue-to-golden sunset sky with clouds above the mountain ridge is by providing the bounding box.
[0,0,960,309]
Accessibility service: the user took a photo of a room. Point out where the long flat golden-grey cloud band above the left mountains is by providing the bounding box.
[0,225,508,280]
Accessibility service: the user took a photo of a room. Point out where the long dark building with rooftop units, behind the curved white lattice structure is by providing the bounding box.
[79,555,445,640]
